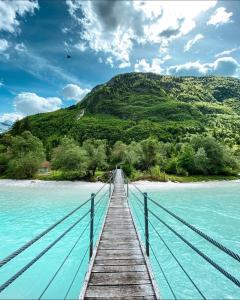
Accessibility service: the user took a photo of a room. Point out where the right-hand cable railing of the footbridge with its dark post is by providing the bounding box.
[122,172,240,299]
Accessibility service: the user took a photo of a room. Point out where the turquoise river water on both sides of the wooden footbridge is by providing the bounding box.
[0,180,240,299]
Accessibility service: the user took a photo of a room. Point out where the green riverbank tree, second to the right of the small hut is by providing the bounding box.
[82,139,107,176]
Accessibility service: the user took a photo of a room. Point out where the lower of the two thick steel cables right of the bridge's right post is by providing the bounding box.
[148,209,240,287]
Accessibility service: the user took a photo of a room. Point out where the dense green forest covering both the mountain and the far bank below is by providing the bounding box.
[0,73,240,180]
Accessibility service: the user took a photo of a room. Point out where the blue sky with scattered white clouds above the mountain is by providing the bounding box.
[0,0,240,122]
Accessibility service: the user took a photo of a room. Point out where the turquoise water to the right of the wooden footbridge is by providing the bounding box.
[130,181,240,299]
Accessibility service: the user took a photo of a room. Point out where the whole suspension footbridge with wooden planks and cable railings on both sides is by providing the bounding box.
[0,169,240,300]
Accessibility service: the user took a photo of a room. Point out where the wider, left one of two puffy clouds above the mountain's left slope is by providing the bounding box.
[14,92,62,116]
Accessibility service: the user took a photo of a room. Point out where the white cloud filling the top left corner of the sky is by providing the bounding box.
[0,0,39,33]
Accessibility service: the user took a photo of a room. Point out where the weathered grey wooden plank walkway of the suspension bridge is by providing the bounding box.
[80,170,157,299]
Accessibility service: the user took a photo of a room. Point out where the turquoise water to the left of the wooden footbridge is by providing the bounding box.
[0,181,108,299]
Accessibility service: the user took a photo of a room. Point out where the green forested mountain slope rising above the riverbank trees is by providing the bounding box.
[12,73,240,146]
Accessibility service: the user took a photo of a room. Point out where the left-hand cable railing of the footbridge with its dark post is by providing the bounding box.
[0,171,116,299]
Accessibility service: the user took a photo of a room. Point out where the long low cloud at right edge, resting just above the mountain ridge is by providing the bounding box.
[167,57,240,76]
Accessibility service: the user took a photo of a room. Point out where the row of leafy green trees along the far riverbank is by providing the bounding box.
[0,131,240,180]
